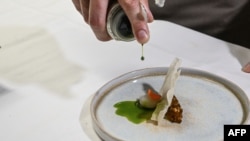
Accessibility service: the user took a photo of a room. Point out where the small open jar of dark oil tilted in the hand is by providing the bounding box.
[107,2,135,42]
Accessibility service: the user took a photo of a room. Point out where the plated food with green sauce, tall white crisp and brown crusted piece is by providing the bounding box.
[114,58,183,126]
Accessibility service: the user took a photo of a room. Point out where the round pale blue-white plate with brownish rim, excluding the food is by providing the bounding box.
[90,67,249,141]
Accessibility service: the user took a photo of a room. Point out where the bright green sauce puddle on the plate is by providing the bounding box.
[114,101,154,124]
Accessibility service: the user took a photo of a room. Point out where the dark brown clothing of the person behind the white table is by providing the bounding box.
[149,0,250,48]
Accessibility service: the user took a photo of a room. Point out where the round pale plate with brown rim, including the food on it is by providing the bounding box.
[90,59,250,141]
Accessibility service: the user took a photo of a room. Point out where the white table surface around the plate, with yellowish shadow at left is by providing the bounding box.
[0,0,250,141]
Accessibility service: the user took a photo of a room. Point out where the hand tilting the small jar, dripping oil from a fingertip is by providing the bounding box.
[72,0,153,44]
